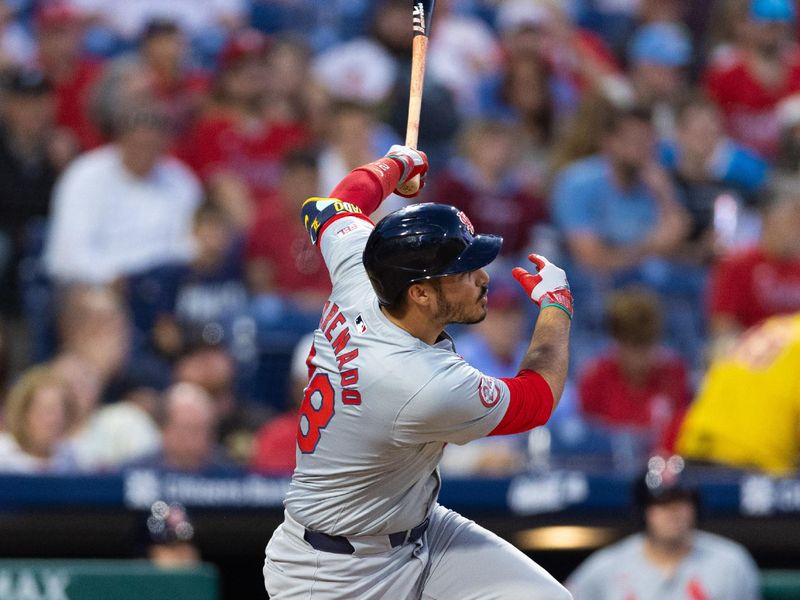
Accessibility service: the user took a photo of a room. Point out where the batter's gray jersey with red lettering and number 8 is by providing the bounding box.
[285,210,509,536]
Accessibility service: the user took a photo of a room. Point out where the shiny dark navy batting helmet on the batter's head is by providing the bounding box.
[363,202,503,304]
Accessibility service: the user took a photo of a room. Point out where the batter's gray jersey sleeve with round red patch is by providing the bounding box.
[394,354,510,444]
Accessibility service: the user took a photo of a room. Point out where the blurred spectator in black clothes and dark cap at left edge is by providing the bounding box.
[0,69,64,314]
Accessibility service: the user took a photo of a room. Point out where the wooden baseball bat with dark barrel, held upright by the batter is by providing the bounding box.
[399,0,436,194]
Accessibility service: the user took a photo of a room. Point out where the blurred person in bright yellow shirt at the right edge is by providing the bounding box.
[676,313,800,477]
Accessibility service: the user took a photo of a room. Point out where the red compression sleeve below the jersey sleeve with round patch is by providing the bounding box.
[489,369,553,435]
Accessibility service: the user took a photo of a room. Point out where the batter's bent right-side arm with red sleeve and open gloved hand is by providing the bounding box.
[490,254,572,435]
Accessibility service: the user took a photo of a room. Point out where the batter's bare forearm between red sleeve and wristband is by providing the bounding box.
[520,306,571,410]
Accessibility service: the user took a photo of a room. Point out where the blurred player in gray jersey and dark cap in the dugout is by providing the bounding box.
[566,456,761,600]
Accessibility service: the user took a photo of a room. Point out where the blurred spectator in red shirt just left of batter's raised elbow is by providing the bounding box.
[246,152,330,314]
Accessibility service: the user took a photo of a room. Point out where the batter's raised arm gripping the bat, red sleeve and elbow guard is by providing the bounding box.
[302,145,428,244]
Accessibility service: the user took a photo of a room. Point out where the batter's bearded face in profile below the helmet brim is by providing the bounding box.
[433,269,489,325]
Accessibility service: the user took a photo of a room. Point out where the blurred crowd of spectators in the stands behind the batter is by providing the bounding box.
[0,0,800,475]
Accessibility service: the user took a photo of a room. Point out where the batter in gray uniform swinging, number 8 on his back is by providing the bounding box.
[264,146,572,600]
